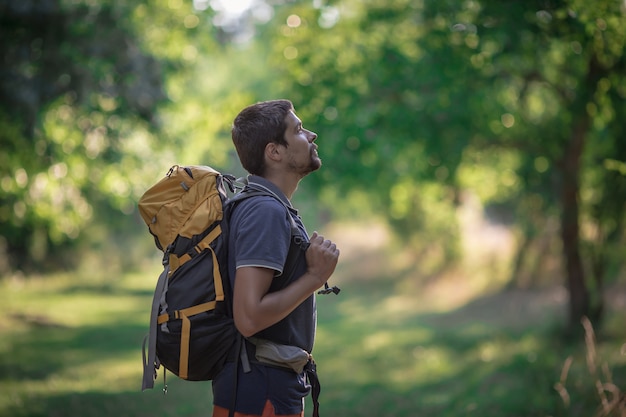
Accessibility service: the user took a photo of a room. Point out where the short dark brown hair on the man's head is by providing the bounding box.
[231,100,293,176]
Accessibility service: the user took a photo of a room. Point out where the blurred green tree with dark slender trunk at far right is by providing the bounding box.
[468,0,626,328]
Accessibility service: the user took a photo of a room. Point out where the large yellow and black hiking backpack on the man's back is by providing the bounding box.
[138,165,306,391]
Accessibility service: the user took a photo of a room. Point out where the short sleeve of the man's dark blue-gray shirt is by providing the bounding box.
[231,197,291,276]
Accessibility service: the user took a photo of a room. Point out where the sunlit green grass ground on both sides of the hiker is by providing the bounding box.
[0,242,626,417]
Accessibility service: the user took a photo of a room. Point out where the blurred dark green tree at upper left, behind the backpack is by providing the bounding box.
[0,0,222,269]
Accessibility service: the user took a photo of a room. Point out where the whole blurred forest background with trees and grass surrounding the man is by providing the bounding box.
[0,0,626,416]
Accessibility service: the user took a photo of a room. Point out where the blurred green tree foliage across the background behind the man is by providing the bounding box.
[0,0,626,308]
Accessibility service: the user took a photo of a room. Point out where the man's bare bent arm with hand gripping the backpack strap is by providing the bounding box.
[233,232,339,337]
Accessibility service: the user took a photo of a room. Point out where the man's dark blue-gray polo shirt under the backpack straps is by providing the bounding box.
[228,176,317,352]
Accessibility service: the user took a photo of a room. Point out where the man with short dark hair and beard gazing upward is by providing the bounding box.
[213,100,339,417]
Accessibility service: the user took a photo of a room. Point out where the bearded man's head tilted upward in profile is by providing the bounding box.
[232,100,321,176]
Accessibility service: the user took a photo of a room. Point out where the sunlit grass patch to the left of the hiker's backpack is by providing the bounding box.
[0,268,168,416]
